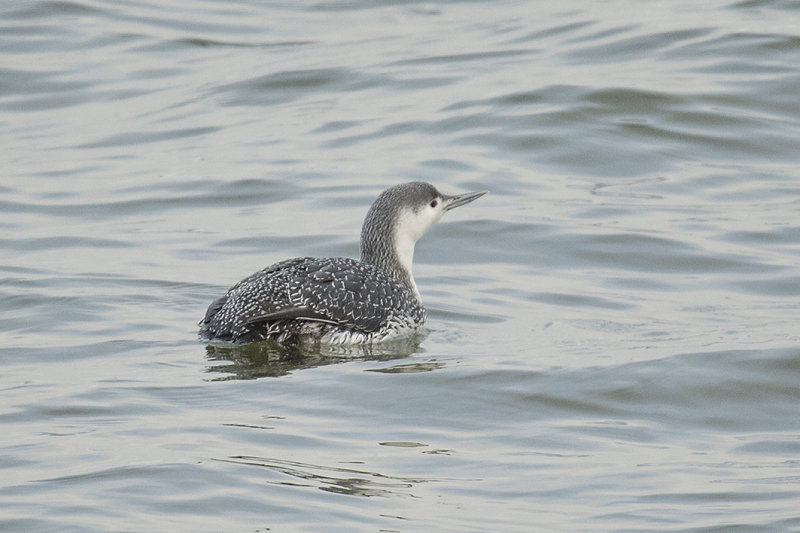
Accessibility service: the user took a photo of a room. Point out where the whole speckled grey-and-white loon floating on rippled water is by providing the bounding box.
[199,181,487,347]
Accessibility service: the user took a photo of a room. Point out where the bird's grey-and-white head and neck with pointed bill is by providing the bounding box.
[361,181,486,292]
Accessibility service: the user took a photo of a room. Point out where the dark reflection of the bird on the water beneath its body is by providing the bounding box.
[206,334,423,381]
